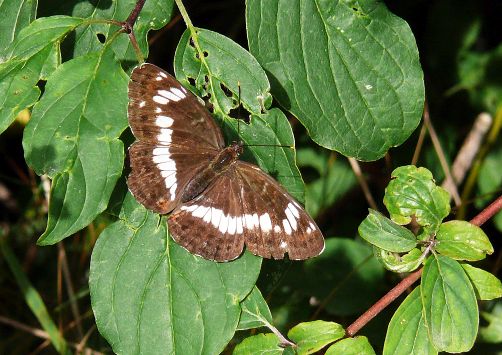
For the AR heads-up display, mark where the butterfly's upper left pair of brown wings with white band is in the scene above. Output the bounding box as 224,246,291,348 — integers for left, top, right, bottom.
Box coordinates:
128,64,224,214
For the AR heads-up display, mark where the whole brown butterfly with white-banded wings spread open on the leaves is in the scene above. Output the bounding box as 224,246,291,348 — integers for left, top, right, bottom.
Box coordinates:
127,63,324,261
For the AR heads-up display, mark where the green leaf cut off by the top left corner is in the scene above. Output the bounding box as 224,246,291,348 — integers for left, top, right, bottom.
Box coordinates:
0,0,38,52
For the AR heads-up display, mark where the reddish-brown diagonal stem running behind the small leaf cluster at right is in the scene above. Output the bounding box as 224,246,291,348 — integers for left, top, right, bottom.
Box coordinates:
346,196,502,337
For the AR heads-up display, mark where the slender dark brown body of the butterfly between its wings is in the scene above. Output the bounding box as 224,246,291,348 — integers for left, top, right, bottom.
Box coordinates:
181,143,242,203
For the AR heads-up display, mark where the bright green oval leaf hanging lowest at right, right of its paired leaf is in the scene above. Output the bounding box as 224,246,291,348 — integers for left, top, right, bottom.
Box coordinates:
420,255,479,352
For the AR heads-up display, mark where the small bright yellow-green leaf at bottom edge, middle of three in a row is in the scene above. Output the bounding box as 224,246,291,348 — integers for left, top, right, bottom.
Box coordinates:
288,320,345,355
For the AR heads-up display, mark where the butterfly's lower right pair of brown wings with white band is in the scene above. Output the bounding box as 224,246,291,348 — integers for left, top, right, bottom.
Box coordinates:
168,161,324,261
